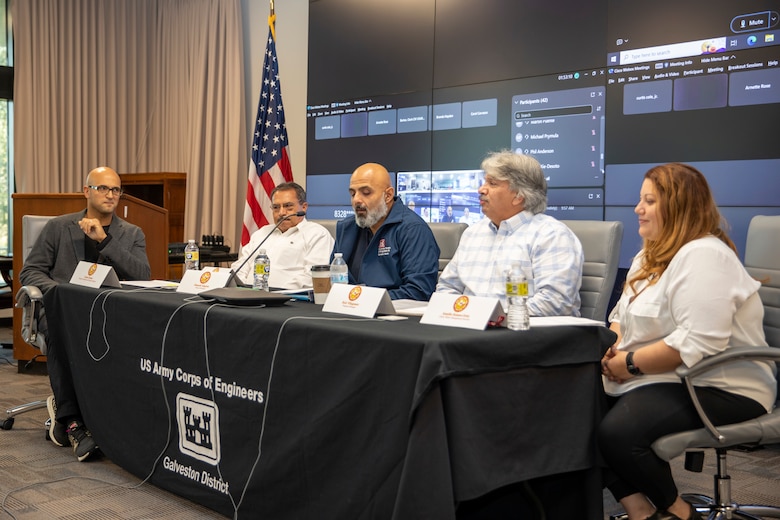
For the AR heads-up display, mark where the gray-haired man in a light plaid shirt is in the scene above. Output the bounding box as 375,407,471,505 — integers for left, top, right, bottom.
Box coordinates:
436,151,584,316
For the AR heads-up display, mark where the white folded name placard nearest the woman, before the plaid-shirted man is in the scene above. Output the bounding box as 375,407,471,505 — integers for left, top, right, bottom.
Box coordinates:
420,293,506,330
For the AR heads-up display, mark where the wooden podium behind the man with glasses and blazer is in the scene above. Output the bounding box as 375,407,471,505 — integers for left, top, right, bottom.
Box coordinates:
11,193,168,367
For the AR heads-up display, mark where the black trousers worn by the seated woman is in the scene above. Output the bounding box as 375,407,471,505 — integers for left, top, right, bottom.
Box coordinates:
598,383,766,509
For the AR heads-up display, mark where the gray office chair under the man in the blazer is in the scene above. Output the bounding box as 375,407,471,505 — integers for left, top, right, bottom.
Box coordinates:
0,215,54,435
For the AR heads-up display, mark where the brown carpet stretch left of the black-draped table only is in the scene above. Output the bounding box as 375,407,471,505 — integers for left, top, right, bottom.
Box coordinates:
0,319,225,520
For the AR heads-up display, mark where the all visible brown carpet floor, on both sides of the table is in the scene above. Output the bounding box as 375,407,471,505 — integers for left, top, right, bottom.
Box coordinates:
0,317,780,520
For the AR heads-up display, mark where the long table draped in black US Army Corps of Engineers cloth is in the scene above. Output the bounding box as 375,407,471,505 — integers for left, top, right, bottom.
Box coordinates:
44,284,614,520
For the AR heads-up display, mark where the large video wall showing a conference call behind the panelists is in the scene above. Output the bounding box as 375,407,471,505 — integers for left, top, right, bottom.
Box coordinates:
306,0,780,267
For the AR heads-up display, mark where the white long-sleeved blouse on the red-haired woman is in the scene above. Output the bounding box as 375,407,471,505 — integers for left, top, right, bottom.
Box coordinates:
604,236,777,411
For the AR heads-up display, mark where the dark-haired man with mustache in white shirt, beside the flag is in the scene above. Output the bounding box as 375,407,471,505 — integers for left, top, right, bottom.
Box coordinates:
230,182,333,289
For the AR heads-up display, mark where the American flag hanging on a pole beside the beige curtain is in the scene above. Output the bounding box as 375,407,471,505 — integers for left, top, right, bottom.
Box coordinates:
241,12,293,246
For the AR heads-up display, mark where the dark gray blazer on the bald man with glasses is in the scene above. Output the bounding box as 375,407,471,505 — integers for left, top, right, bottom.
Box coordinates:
19,209,151,293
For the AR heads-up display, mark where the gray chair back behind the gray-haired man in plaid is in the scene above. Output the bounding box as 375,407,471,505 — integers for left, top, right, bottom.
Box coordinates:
561,220,623,321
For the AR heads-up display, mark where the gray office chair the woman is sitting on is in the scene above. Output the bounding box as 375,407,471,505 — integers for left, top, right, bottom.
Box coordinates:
653,216,780,520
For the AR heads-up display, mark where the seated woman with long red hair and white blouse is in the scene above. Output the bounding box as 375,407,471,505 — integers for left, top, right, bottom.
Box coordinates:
599,163,777,520
